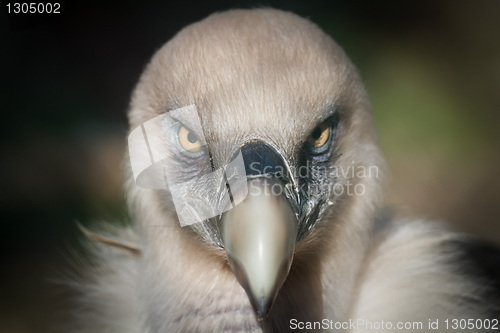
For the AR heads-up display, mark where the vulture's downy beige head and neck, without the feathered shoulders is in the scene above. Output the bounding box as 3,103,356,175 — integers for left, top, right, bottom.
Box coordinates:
128,10,382,331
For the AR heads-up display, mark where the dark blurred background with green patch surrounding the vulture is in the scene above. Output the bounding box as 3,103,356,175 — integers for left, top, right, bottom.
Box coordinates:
0,0,500,333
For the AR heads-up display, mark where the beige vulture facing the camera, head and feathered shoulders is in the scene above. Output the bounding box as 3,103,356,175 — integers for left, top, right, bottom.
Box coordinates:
74,9,500,333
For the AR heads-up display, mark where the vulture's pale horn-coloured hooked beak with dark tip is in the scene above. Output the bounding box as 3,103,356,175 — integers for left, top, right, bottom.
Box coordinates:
221,142,298,320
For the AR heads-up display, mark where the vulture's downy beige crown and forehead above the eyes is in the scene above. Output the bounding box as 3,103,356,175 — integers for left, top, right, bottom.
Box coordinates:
130,11,358,160
